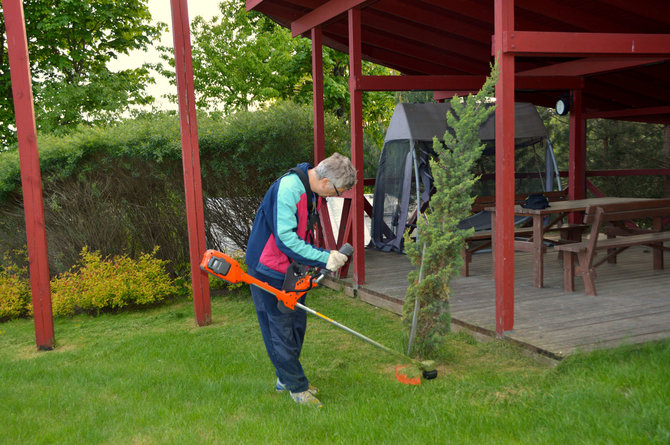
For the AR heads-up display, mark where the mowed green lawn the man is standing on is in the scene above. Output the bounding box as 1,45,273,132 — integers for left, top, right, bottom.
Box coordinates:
0,289,670,444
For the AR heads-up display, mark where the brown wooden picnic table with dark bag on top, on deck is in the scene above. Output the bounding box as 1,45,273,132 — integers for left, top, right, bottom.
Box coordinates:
486,196,649,287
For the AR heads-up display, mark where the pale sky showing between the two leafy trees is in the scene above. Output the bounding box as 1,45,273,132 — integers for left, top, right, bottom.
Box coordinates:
110,0,221,109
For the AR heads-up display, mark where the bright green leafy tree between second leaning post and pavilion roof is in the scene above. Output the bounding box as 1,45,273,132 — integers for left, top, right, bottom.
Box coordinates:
157,0,395,146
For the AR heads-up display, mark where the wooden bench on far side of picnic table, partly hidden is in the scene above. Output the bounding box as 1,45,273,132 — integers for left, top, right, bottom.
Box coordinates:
461,190,587,277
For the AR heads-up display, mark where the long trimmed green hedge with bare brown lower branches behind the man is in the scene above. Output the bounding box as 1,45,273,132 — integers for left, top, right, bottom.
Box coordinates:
0,103,349,274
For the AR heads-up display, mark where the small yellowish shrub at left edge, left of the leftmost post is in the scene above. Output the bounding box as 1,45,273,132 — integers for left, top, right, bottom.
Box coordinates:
0,251,33,321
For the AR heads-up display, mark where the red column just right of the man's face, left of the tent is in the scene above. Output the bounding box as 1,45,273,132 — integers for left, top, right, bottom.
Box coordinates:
350,7,365,286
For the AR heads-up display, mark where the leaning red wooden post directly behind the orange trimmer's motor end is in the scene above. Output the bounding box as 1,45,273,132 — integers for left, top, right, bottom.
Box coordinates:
170,0,212,326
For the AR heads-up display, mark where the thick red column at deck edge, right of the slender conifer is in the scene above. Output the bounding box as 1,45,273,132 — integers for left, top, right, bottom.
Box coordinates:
494,0,515,336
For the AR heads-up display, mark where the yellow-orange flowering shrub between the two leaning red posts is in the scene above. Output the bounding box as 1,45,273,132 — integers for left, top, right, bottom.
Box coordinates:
51,247,180,315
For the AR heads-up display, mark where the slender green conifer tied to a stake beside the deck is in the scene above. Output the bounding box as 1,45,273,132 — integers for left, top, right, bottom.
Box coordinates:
403,67,497,356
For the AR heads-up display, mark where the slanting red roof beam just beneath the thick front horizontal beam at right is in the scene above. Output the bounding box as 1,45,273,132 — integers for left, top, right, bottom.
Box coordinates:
516,56,668,77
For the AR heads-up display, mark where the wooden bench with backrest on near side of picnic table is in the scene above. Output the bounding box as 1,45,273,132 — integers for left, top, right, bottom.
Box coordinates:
554,199,670,295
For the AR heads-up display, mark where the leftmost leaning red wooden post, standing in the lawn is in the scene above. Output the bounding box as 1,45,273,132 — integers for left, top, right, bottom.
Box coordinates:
2,0,55,350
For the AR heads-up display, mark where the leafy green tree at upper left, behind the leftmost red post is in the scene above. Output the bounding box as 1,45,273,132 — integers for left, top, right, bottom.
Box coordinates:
0,0,164,147
